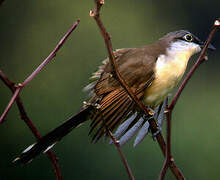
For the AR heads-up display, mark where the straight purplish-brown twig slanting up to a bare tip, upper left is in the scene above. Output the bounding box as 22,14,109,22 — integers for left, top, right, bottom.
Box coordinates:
0,19,80,123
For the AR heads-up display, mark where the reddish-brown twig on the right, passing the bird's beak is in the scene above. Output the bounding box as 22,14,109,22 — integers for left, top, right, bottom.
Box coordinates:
159,19,220,180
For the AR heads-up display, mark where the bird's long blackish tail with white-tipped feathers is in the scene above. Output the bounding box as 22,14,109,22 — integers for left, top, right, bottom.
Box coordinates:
13,106,93,164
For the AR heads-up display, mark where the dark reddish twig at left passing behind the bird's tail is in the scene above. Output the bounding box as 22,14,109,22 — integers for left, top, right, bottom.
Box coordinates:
0,70,62,180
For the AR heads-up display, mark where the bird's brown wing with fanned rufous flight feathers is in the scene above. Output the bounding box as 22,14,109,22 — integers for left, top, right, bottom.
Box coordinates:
85,47,159,141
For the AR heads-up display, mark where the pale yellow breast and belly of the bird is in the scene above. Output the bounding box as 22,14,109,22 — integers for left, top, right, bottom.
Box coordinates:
143,52,191,108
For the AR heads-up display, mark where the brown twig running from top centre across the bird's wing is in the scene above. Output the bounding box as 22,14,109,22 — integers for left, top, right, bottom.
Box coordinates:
90,0,184,180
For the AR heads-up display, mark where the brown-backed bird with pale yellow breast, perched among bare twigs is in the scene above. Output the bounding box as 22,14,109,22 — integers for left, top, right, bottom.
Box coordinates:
14,30,215,164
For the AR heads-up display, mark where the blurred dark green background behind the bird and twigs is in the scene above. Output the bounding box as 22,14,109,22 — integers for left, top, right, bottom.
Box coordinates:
0,0,220,180
